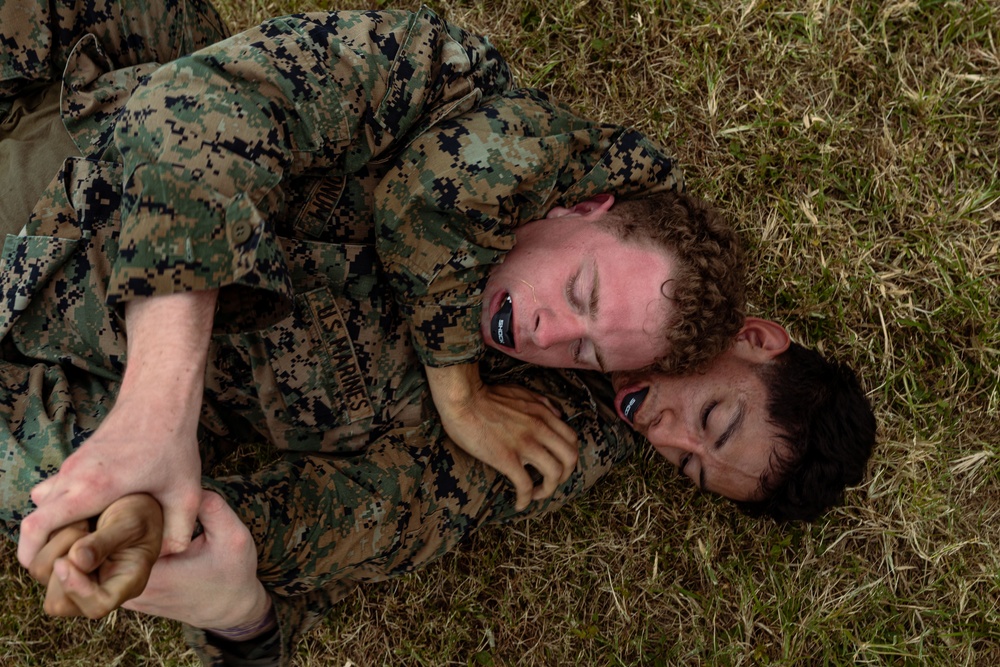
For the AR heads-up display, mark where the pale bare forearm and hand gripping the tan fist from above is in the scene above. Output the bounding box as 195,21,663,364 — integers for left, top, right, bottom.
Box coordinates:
17,291,217,567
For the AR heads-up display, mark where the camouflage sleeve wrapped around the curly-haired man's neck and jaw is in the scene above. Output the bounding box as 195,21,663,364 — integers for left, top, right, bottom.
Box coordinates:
375,89,680,366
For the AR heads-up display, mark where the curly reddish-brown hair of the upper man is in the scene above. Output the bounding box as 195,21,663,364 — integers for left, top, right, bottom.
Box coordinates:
598,190,746,373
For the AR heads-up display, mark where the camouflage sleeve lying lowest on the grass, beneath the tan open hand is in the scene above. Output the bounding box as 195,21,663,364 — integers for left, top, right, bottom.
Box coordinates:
205,362,636,656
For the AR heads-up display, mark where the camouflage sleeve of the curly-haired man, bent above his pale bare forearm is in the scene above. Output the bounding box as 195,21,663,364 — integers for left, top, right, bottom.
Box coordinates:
109,9,509,331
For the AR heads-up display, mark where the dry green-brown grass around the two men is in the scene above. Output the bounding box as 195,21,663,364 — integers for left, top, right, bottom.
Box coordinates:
0,0,1000,667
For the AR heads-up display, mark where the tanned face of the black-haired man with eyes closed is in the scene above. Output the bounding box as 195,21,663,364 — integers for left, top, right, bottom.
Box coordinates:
614,343,783,500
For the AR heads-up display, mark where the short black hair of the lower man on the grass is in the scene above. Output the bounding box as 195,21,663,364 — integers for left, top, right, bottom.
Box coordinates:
737,343,876,521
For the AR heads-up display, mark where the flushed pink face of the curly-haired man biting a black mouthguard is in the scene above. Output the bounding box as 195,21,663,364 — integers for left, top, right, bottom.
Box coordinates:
481,201,674,371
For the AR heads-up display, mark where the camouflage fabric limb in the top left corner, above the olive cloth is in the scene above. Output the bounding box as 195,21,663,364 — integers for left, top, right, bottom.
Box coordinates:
0,0,229,98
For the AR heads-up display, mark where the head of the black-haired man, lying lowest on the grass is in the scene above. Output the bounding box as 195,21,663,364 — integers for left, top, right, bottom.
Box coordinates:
614,317,875,520
